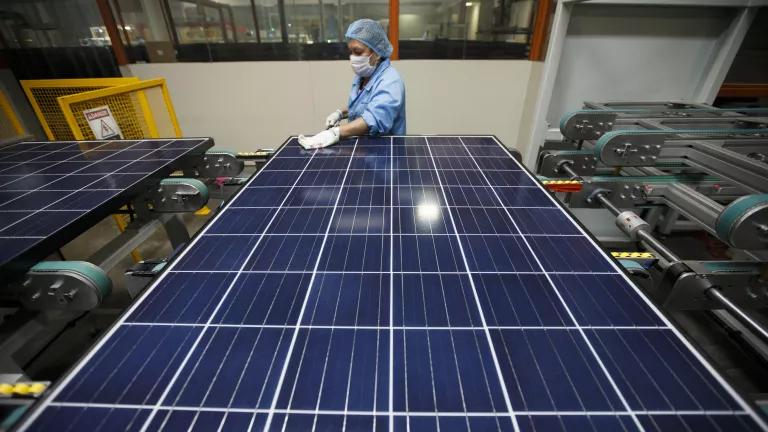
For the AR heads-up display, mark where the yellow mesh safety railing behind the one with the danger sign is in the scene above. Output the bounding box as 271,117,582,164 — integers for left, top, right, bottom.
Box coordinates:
21,77,139,141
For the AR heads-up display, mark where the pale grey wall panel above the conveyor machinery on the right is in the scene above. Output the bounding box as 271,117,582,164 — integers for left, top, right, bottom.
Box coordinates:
547,3,736,127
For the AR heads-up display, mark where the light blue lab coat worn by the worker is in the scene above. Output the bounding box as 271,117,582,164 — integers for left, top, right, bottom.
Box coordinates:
347,59,405,135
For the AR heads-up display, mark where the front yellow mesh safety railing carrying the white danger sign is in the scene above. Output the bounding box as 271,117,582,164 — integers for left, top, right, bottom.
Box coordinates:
57,78,181,140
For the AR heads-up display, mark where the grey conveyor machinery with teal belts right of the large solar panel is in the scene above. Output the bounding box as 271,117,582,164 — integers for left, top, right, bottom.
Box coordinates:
537,101,768,410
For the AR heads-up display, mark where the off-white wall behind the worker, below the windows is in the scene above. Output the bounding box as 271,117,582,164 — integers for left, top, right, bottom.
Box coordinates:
129,60,532,151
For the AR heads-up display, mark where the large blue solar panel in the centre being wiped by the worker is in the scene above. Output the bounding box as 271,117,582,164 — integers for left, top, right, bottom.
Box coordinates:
15,137,765,431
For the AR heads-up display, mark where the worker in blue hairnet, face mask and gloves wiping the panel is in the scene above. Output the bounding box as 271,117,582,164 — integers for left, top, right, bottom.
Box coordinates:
299,19,405,149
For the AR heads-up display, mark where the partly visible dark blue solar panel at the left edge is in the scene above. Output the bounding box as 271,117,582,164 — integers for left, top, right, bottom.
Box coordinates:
0,138,213,272
